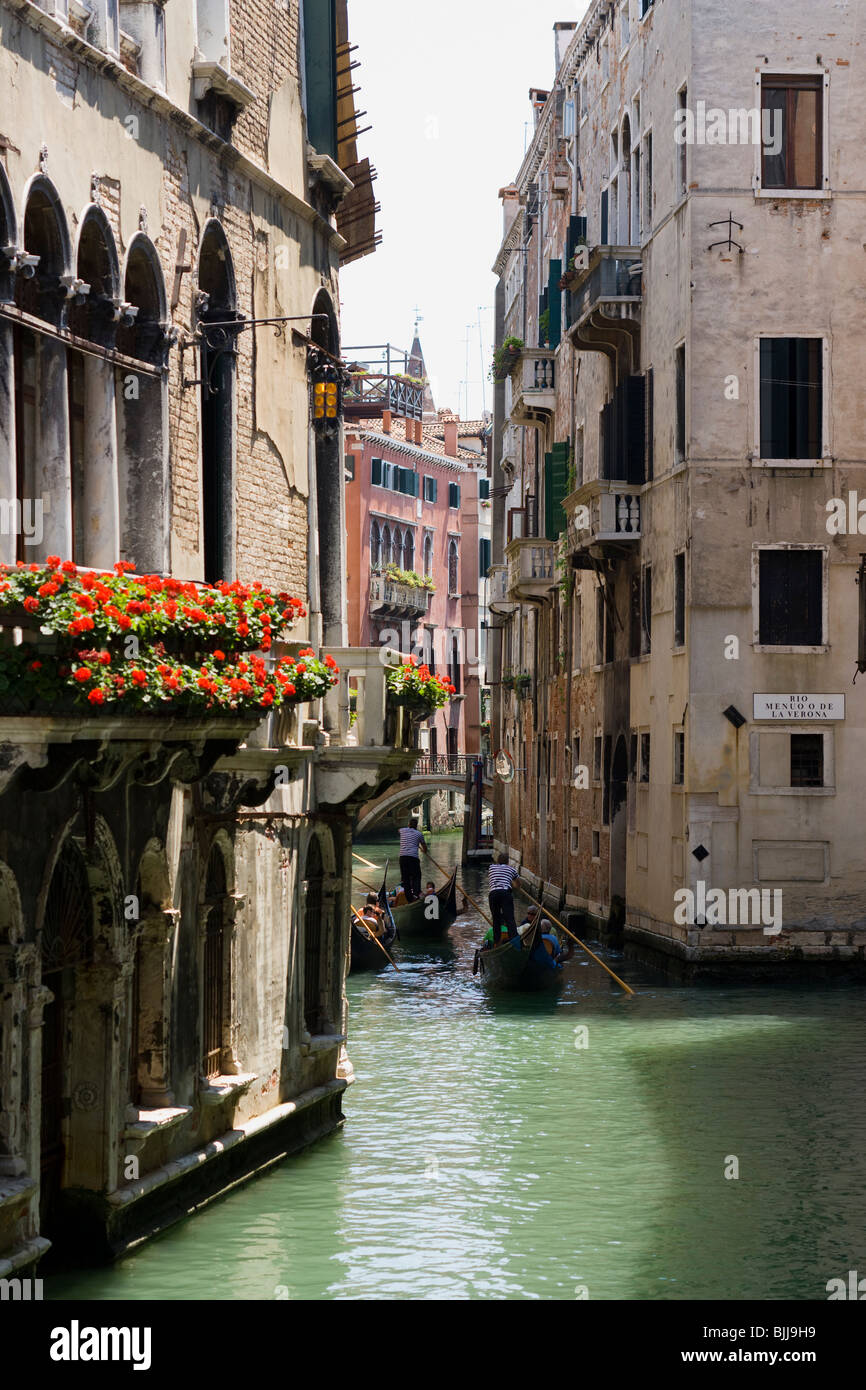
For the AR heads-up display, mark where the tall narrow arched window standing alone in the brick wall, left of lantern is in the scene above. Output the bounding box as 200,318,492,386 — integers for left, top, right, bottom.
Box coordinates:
197,218,238,584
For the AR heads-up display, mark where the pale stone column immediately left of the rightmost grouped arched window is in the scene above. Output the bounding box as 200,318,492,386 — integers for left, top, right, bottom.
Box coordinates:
81,354,121,570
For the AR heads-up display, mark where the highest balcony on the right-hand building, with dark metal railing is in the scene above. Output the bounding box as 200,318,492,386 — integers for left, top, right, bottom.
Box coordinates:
567,246,644,371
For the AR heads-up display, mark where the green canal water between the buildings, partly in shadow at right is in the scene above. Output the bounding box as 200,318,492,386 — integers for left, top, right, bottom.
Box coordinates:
46,837,866,1300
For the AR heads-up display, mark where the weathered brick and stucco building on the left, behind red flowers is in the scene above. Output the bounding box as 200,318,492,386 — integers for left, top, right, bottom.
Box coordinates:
0,0,411,1273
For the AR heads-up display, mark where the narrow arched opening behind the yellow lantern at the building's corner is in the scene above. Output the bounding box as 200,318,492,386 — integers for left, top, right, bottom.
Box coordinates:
310,289,346,646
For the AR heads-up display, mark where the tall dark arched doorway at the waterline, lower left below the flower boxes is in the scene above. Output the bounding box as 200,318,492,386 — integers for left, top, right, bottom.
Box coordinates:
40,840,93,1233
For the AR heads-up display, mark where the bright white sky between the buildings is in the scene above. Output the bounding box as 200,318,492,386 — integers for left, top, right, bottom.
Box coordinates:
341,0,587,418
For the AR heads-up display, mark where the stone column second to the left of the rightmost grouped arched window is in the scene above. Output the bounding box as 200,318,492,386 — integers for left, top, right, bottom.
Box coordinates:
28,334,72,560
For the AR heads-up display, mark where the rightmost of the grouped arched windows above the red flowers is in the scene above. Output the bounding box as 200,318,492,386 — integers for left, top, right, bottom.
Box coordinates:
117,232,170,574
